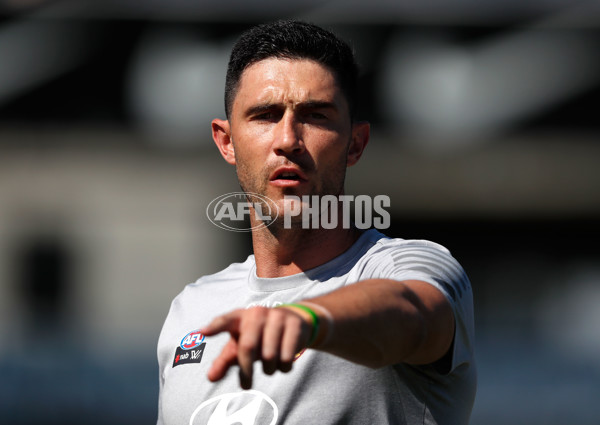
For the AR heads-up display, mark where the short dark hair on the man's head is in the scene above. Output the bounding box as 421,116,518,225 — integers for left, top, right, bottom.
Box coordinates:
225,20,358,118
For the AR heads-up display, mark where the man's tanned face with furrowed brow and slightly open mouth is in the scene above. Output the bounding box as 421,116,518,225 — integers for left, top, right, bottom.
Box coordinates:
221,58,362,210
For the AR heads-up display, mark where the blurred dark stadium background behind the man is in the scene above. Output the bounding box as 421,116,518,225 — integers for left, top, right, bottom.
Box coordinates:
0,0,600,425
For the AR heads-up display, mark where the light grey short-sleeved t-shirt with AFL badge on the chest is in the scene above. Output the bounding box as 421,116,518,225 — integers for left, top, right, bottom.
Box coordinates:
158,230,476,425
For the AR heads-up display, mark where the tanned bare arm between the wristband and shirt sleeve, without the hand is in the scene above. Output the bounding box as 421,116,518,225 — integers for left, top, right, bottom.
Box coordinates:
286,279,454,367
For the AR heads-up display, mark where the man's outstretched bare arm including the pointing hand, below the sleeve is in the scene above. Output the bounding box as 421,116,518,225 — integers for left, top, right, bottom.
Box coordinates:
201,279,454,389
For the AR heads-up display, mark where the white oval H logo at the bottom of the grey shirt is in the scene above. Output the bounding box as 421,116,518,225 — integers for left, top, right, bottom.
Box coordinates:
189,390,279,425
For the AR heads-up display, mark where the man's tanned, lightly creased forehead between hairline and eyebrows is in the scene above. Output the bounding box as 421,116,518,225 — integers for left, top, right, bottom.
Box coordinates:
233,58,347,113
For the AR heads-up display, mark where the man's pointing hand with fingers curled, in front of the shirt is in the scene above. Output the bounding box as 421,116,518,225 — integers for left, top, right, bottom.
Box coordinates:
201,307,312,389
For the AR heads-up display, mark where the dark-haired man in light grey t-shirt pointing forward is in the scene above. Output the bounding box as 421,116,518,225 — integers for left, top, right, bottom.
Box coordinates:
158,21,476,425
